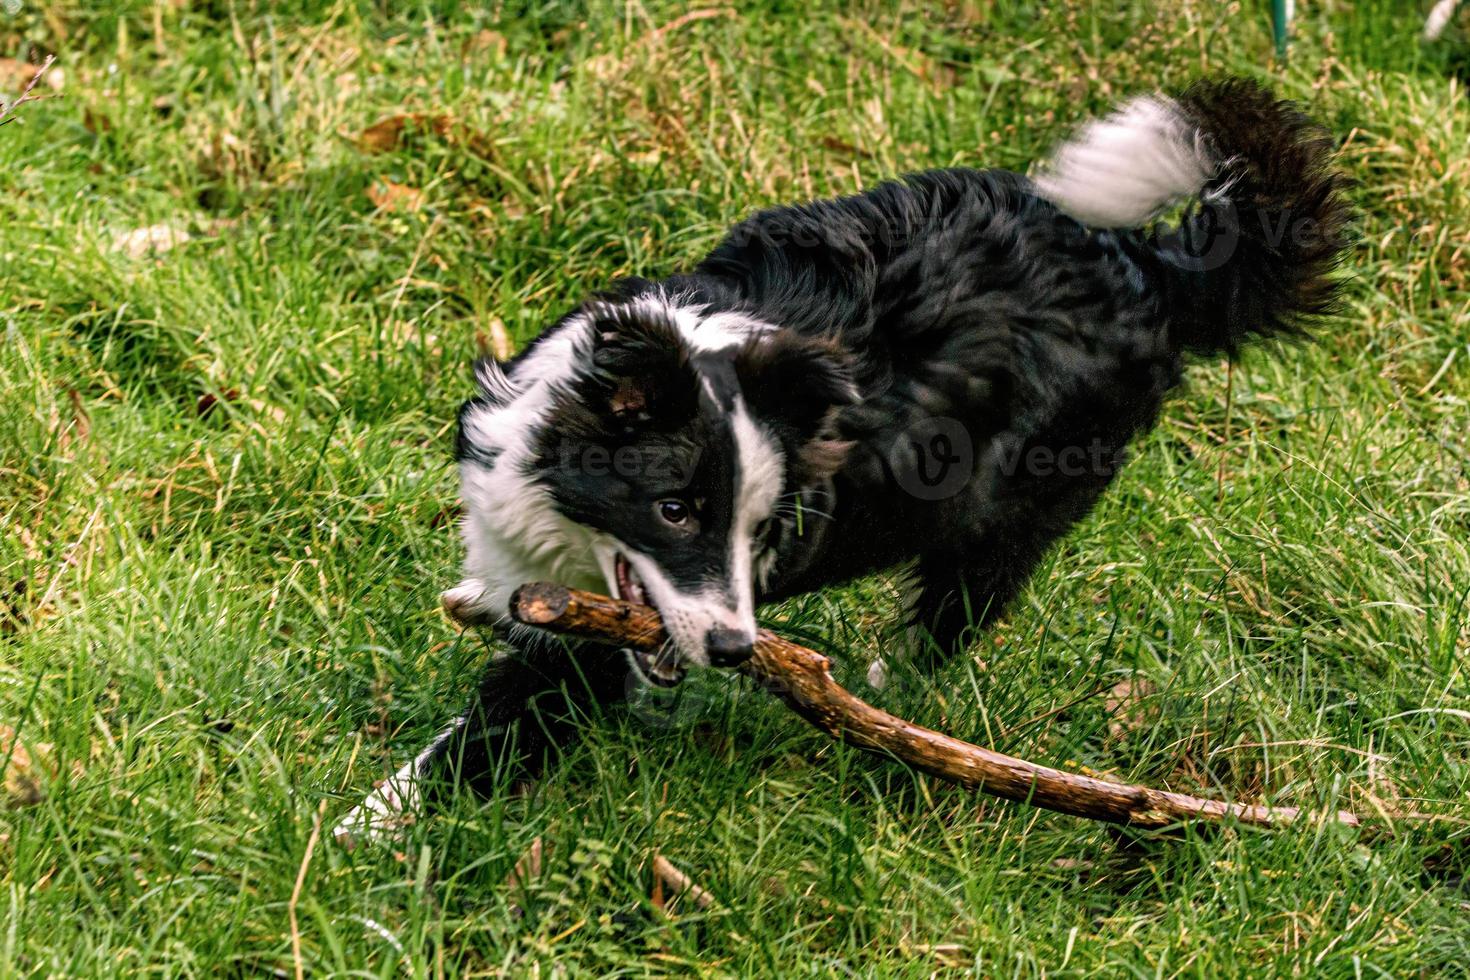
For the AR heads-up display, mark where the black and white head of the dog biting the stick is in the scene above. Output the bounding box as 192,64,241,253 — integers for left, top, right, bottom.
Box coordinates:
462,300,856,683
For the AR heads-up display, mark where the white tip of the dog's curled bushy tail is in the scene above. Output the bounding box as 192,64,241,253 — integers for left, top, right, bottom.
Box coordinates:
1035,96,1216,228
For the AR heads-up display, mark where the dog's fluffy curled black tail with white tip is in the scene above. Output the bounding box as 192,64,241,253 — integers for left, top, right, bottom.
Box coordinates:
1035,79,1351,354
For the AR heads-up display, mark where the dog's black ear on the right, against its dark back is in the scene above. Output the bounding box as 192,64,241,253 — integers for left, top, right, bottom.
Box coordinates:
735,331,858,435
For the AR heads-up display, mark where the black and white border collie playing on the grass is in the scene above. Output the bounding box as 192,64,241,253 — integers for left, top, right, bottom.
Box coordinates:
338,79,1349,836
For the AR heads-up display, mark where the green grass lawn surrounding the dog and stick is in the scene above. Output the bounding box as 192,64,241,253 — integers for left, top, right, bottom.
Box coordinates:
0,0,1470,977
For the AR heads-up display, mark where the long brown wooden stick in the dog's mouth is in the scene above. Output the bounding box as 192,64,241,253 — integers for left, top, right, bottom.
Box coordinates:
510,582,1361,829
